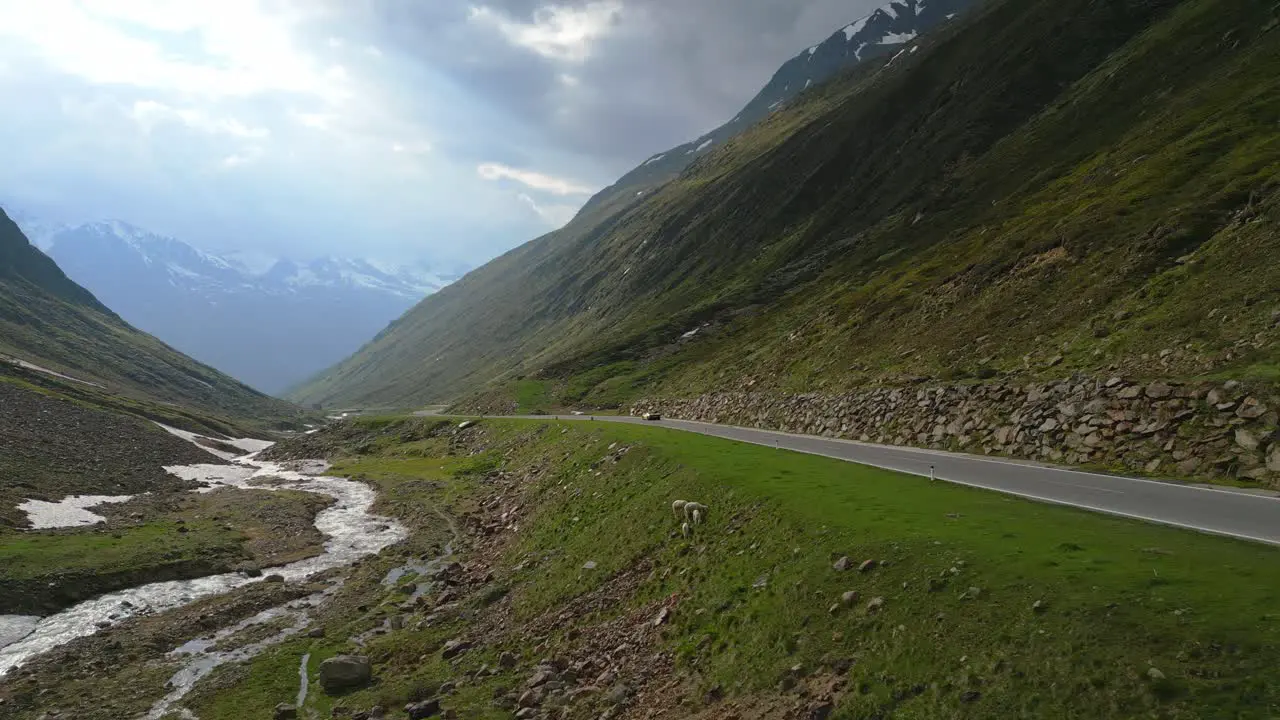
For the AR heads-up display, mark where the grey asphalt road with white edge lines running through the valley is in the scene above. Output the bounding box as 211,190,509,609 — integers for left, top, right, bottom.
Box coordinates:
481,415,1280,544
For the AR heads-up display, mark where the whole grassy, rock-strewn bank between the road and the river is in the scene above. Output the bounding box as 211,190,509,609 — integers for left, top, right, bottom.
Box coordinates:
99,419,1280,720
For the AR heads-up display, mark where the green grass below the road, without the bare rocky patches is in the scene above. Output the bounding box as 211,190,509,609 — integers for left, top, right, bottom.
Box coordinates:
180,420,1280,719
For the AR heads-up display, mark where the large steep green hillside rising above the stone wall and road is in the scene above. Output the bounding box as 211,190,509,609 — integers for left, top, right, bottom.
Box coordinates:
293,0,1280,405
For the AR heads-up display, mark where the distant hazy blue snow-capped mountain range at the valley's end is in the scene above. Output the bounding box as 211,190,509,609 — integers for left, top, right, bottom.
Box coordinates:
18,215,453,393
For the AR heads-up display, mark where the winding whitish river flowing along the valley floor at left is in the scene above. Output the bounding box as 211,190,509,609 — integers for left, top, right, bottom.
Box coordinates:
0,443,407,675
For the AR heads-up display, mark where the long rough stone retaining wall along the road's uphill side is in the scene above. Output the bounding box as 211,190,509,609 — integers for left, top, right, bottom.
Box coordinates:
631,377,1280,487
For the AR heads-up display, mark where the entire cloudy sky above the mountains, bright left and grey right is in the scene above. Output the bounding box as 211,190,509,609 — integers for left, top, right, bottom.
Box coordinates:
0,0,878,264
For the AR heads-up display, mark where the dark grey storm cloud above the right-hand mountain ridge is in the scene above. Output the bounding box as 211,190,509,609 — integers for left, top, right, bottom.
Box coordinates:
367,0,882,170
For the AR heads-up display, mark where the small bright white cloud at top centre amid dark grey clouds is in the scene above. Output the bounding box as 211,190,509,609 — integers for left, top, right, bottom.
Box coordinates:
470,0,622,63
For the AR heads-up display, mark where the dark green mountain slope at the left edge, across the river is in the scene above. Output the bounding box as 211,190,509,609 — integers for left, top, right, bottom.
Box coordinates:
0,210,298,419
